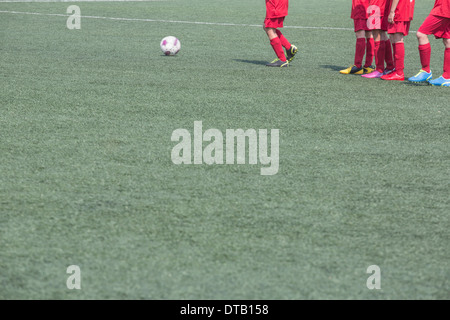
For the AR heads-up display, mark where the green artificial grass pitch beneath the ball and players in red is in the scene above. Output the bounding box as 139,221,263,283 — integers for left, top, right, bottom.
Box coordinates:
0,0,450,300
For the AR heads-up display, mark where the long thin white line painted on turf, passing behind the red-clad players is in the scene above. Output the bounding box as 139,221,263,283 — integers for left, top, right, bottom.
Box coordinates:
0,9,353,31
